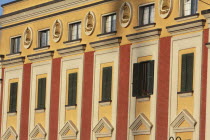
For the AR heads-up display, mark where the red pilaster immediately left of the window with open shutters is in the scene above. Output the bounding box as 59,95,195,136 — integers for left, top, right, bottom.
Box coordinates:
116,45,130,140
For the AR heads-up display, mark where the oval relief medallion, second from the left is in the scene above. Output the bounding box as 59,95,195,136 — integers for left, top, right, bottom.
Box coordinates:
52,19,63,42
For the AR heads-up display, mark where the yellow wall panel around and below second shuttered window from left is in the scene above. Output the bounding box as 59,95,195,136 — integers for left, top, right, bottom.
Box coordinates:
34,74,47,127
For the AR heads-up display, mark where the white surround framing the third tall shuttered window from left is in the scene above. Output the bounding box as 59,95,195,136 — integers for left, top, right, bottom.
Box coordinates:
58,55,84,140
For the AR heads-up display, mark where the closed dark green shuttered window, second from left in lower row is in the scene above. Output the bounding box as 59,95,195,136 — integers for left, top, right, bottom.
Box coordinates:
37,78,46,109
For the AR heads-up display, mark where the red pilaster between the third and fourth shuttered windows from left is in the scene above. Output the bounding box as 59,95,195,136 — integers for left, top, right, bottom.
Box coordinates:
80,52,94,140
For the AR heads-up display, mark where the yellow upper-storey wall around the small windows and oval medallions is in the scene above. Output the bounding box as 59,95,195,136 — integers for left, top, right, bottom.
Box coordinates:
0,0,209,63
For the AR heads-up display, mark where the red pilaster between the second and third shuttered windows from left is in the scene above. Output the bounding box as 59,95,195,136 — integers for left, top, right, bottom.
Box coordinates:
49,58,61,140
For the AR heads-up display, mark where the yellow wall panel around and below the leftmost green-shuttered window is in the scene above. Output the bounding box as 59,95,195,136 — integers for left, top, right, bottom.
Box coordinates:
7,79,19,129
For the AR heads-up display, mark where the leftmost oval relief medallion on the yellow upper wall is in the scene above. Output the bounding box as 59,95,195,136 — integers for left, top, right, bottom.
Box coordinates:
23,27,33,49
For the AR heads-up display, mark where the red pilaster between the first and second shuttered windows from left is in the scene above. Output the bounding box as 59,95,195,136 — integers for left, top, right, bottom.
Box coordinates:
20,64,31,140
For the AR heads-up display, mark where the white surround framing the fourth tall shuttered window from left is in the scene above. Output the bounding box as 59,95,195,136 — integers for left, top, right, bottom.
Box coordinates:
91,48,119,140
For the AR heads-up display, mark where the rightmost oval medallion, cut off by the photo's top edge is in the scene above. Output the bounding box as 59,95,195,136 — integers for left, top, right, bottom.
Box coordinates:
159,0,172,18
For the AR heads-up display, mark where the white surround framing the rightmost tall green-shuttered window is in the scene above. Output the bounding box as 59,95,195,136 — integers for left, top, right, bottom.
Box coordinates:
168,32,203,140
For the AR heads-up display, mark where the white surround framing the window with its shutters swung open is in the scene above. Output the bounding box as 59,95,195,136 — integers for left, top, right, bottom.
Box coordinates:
128,40,159,140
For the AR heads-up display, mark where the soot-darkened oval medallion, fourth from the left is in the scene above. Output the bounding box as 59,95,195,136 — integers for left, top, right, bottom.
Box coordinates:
119,2,132,28
